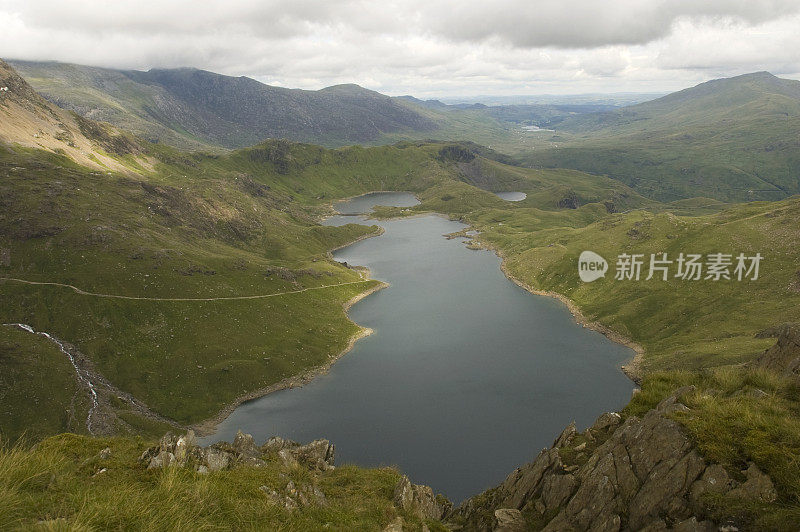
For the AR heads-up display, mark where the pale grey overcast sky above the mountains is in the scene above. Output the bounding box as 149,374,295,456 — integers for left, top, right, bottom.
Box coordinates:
0,0,800,98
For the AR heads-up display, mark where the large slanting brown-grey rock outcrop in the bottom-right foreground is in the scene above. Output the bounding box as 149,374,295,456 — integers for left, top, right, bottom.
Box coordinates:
454,387,777,531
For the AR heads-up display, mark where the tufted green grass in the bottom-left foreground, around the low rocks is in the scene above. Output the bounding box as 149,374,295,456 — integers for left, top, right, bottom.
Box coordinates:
0,434,432,531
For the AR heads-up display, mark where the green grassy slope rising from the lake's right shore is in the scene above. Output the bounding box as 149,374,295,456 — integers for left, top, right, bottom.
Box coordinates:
477,200,800,369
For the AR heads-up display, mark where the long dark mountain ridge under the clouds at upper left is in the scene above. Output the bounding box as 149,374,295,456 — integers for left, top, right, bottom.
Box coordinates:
6,61,436,149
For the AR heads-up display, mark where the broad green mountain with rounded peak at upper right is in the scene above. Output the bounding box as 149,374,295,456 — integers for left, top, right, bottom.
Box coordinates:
524,72,800,201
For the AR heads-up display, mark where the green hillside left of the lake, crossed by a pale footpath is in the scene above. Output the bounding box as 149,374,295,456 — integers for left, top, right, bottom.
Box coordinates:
0,142,390,432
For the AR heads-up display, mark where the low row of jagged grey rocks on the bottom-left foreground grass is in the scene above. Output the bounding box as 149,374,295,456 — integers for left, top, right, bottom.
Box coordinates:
139,430,334,473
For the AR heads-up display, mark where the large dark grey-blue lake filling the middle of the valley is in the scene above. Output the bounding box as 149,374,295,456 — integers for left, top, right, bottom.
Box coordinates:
204,193,634,503
